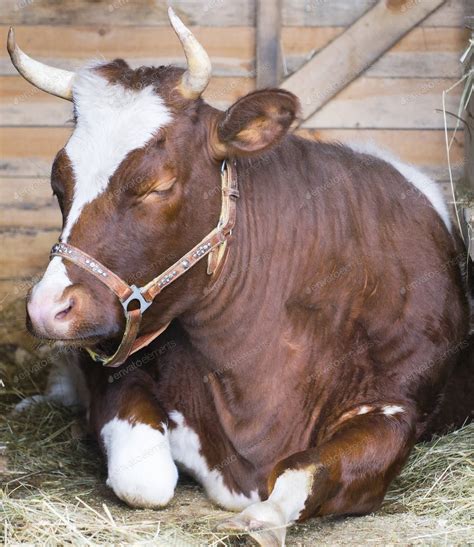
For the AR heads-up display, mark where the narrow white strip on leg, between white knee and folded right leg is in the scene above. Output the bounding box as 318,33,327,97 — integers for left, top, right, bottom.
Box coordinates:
170,410,260,511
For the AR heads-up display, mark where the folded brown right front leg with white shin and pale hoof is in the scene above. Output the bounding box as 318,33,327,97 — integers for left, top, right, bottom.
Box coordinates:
219,404,415,545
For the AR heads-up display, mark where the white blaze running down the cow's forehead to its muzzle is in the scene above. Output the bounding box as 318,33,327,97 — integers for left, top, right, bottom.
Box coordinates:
31,65,172,314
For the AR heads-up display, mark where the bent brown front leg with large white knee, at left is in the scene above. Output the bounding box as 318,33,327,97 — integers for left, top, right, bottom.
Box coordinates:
90,371,178,508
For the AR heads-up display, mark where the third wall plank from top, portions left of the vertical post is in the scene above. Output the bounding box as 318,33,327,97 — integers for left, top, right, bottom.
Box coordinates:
0,76,255,126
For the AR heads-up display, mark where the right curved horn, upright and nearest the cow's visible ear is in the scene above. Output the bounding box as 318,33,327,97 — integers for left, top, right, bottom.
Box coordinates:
168,7,212,99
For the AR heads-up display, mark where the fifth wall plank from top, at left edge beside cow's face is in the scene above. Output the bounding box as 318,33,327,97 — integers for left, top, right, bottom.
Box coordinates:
0,177,61,230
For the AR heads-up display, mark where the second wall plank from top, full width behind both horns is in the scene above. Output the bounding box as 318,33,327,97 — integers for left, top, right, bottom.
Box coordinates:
0,25,469,78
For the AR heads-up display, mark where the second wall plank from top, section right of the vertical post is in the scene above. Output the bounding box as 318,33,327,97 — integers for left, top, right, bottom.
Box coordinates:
282,26,469,78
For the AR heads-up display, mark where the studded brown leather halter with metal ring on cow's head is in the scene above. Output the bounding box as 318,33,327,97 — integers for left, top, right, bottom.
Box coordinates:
50,160,239,367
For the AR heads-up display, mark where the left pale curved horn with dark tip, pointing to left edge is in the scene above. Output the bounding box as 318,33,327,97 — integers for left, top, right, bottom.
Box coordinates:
7,27,75,101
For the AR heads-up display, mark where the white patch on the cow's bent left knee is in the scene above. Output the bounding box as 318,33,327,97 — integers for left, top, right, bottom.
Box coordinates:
101,418,178,508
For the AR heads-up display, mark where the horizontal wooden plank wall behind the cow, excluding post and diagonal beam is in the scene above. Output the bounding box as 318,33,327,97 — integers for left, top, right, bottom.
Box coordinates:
0,0,471,306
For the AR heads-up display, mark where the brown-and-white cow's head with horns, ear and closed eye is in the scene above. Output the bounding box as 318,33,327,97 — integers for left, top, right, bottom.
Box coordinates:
8,8,298,345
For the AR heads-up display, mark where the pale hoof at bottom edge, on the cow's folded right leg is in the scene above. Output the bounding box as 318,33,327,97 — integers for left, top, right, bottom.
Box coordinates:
217,514,286,547
